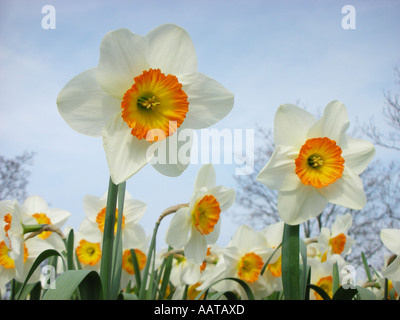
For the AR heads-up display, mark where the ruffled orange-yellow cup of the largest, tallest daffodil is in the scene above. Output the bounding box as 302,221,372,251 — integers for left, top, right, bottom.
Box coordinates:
121,69,189,142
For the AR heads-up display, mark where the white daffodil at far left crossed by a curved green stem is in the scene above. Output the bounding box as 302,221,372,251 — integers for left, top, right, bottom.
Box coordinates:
21,196,71,252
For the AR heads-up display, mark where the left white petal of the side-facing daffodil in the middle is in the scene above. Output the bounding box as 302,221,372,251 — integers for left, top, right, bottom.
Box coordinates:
165,207,191,249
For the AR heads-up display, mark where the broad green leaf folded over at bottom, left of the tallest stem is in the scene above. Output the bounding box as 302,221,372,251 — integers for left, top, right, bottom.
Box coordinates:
43,270,103,300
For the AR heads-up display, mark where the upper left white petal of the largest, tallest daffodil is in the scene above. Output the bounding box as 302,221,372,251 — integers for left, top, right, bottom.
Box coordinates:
96,29,148,99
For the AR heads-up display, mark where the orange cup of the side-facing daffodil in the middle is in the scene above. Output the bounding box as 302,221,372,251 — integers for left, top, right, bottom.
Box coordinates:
192,195,221,235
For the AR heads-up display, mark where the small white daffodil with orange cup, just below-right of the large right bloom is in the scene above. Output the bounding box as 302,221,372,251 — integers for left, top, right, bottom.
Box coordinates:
318,213,355,262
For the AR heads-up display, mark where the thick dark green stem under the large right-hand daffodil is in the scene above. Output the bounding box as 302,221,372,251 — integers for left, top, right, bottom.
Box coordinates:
282,223,301,300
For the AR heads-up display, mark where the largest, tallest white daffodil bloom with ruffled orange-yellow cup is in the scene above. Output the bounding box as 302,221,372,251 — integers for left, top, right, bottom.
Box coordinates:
57,24,233,184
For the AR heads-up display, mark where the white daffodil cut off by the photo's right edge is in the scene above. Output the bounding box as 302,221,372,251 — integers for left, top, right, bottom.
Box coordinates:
381,229,400,285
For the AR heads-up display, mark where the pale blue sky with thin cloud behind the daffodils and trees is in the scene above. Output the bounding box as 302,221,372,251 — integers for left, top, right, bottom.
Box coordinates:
0,0,400,245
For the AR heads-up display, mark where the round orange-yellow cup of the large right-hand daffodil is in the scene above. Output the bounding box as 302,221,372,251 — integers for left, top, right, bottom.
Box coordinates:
295,138,344,188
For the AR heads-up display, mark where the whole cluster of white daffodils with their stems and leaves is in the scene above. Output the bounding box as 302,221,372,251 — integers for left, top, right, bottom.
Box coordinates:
0,24,400,300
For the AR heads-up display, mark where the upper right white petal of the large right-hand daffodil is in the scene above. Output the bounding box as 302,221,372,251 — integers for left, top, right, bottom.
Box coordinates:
307,101,350,145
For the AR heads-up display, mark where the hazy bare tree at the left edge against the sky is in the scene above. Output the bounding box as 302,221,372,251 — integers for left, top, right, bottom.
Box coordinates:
0,151,34,202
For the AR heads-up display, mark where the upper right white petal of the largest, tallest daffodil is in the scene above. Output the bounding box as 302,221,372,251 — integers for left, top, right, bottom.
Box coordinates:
146,24,197,75
